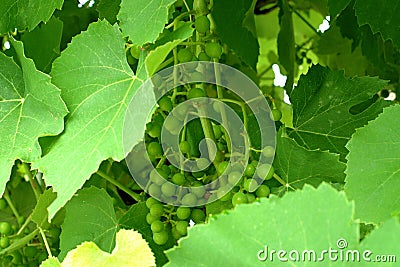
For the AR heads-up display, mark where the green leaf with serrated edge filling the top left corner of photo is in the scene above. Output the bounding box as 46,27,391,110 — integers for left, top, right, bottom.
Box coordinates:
0,0,64,34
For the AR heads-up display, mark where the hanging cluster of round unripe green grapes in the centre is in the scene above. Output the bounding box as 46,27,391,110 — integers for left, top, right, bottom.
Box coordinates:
131,0,282,245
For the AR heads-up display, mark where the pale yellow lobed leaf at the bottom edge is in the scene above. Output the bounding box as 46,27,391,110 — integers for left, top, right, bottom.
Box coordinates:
40,230,155,267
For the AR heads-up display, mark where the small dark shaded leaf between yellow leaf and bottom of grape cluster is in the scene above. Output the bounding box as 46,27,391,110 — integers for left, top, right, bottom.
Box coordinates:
118,202,174,266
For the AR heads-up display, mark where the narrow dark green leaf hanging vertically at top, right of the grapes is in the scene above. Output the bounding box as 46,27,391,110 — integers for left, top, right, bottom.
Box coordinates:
278,0,295,94
